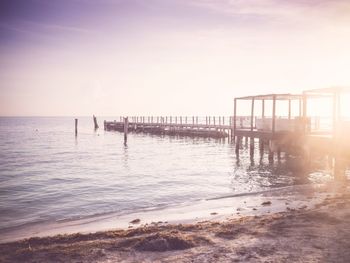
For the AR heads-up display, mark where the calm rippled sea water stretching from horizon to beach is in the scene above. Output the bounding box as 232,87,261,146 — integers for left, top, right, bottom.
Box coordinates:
0,117,329,233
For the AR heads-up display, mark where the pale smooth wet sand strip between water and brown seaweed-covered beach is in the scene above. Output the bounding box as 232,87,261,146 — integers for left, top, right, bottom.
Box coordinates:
0,184,334,244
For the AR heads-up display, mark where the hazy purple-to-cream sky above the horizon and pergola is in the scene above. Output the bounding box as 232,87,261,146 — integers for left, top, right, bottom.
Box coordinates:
0,0,350,116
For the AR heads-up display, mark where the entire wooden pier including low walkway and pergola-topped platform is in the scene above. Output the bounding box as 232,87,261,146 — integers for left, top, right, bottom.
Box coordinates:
104,88,350,178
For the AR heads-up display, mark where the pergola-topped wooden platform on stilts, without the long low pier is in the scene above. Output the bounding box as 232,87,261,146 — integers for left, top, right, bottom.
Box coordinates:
233,88,350,179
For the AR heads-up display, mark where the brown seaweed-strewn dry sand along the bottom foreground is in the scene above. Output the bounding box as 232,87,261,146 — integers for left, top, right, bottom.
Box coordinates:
0,188,350,263
